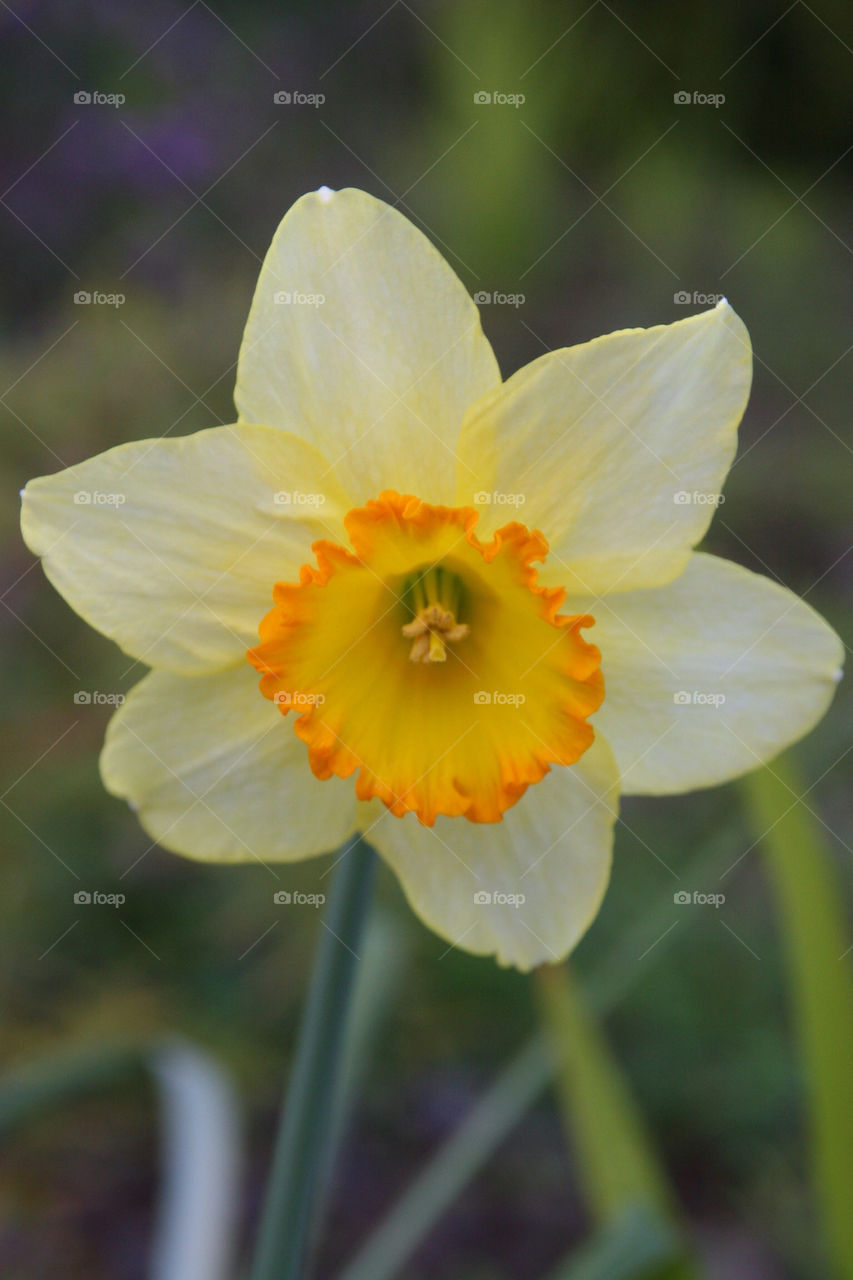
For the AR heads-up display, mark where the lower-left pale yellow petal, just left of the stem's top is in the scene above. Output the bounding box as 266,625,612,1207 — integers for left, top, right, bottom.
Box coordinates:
101,664,356,863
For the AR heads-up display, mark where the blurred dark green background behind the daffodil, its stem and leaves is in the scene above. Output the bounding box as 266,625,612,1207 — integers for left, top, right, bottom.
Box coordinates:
0,0,853,1280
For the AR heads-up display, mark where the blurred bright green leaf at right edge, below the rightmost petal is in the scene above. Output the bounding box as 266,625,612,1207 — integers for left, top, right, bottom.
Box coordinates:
743,758,853,1280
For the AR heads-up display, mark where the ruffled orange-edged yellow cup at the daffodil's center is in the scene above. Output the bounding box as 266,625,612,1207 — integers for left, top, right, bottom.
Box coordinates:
248,490,605,826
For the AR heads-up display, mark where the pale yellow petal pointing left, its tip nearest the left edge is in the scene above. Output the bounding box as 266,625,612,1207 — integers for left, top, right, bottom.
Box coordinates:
22,426,350,673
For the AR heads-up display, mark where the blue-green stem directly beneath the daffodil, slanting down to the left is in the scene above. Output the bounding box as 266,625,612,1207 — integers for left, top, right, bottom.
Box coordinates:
251,836,375,1280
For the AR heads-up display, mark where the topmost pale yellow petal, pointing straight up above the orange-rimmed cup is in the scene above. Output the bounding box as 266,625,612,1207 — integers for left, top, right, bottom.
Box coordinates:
236,189,501,502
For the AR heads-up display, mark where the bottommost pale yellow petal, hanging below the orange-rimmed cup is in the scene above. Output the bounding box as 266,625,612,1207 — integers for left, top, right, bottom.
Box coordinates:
368,736,617,969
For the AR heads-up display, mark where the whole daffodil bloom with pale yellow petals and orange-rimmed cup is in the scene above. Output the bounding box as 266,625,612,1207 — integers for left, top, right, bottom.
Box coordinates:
23,188,841,969
